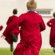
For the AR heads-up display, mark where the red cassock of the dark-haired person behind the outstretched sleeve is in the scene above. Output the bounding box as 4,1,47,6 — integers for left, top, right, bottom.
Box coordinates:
5,16,19,44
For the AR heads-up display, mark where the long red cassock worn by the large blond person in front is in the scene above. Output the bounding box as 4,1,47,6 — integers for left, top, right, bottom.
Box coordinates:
3,11,45,55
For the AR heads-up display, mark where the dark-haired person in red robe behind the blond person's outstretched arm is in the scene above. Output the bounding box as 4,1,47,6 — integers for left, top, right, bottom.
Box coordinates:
5,9,19,44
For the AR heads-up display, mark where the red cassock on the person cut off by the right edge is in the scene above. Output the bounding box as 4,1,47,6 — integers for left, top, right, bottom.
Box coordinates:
47,19,55,47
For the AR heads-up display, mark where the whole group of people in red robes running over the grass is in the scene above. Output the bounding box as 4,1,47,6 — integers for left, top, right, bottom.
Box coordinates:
0,0,55,55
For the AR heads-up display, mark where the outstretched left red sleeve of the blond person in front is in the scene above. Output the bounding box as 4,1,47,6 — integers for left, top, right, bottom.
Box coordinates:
3,14,24,36
